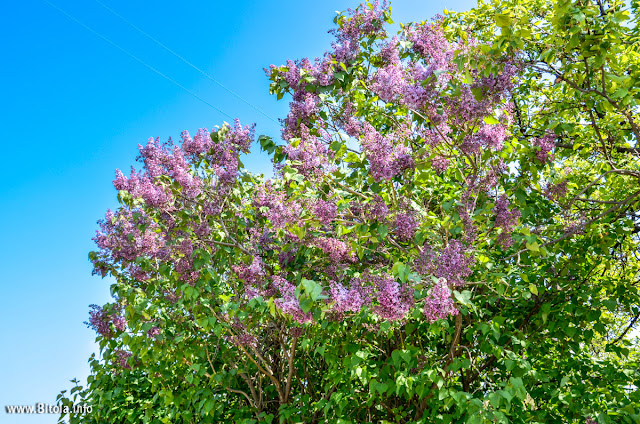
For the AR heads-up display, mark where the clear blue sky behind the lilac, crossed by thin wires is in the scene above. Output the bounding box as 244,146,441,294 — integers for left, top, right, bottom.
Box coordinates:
0,0,475,424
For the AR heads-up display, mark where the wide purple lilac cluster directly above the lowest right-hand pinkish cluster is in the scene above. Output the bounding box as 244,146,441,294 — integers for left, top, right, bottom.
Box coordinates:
415,240,474,287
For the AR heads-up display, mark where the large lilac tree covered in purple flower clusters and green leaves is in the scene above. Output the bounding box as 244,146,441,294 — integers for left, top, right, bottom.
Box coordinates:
61,3,639,423
